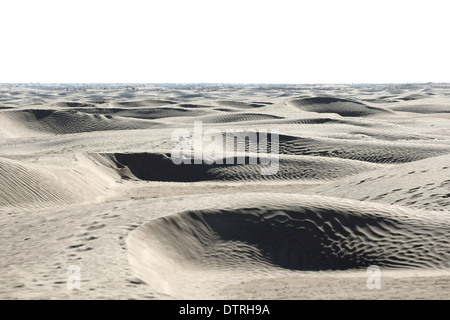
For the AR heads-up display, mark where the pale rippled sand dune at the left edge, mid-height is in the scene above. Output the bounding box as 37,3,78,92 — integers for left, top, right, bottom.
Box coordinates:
0,156,117,207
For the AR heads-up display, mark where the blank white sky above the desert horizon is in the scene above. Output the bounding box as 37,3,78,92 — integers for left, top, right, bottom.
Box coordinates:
0,0,450,83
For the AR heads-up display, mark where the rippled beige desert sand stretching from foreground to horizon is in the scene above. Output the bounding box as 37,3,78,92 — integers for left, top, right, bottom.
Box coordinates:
0,84,450,299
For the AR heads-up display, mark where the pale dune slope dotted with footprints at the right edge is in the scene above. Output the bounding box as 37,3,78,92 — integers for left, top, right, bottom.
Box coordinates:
313,155,450,210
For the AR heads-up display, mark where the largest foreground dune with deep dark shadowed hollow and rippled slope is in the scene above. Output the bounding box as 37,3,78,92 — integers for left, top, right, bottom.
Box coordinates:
127,194,450,292
